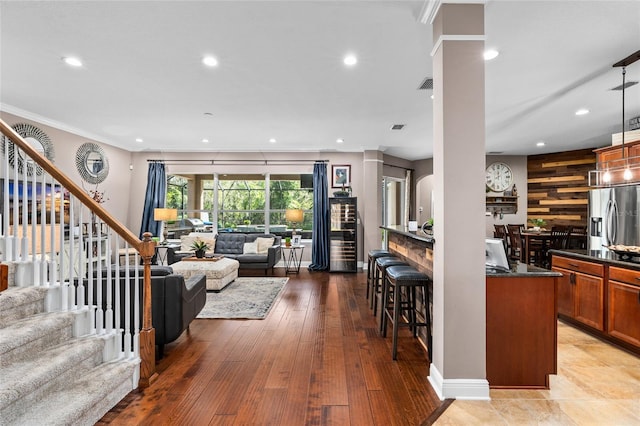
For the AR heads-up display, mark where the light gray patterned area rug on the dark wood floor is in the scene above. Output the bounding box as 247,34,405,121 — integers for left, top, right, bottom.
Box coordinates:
197,277,289,319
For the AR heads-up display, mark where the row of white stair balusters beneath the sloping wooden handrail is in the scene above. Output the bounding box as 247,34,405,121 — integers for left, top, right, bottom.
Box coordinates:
0,131,144,385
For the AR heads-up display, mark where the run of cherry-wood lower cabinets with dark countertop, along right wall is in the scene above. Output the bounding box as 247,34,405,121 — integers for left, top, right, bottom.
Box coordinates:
550,248,640,355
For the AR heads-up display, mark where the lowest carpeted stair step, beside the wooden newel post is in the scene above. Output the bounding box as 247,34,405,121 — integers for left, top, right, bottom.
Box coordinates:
6,361,137,425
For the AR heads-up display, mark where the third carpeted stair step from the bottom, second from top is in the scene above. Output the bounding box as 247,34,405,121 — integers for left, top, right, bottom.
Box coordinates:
0,312,76,366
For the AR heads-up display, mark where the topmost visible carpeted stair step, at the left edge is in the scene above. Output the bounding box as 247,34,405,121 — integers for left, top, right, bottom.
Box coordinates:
0,287,48,329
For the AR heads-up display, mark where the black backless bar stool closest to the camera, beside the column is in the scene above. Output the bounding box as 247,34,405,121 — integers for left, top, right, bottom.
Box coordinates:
381,266,433,360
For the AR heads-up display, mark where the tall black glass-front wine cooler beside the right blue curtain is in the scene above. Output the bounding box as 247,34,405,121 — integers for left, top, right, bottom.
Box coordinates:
329,197,358,272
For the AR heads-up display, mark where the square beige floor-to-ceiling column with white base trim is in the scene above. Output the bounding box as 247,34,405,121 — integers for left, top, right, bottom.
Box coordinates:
429,3,489,399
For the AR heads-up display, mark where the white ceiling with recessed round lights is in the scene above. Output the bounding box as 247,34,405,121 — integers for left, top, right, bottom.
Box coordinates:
0,0,640,160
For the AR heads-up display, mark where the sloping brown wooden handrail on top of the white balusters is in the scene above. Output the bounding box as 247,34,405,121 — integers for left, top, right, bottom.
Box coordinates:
0,119,142,252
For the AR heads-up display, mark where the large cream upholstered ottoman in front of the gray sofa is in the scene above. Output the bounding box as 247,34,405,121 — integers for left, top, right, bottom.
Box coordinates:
171,257,240,291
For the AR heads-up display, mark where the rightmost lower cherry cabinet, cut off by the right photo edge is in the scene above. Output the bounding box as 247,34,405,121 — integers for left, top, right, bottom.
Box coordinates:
607,266,640,347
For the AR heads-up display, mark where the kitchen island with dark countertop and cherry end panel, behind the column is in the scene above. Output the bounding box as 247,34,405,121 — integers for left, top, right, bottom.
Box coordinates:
381,227,562,389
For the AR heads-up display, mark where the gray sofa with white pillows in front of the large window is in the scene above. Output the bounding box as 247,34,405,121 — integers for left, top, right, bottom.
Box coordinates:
214,232,282,273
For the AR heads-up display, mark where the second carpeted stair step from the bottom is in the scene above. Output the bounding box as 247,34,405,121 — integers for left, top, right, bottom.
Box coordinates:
0,337,105,410
